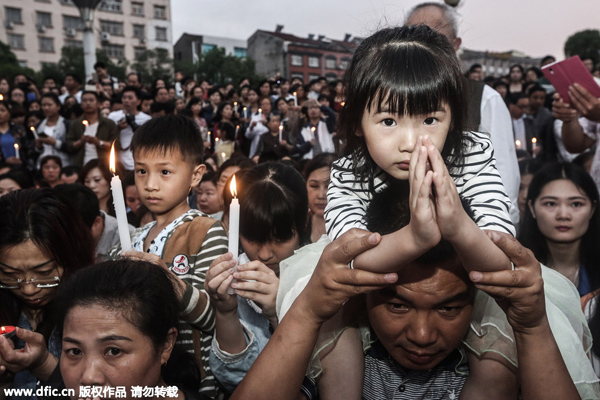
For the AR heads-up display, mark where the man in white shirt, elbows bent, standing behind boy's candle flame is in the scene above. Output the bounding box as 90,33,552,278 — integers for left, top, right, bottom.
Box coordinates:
108,86,150,171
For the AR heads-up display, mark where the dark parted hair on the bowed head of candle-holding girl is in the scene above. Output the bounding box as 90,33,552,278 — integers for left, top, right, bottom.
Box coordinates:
237,162,310,245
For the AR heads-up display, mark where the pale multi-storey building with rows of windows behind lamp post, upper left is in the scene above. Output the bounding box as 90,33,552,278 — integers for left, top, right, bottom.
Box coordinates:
0,0,173,70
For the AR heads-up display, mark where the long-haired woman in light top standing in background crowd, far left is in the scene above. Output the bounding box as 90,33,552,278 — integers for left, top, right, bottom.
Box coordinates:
35,93,71,167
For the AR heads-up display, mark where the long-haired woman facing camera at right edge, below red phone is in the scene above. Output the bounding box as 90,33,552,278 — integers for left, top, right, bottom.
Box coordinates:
519,163,600,296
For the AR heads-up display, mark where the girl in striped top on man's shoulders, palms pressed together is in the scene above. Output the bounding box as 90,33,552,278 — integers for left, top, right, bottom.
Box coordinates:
320,26,592,399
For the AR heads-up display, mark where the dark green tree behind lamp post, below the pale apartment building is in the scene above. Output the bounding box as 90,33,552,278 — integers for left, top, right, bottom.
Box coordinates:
40,46,128,82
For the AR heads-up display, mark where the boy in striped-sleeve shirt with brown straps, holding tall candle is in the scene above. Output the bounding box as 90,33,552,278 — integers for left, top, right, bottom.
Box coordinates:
110,115,228,397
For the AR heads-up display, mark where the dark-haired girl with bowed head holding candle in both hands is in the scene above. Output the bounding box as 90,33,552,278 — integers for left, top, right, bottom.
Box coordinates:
204,163,309,391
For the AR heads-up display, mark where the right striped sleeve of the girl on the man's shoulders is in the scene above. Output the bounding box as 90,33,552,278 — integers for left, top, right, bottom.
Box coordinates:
452,132,516,236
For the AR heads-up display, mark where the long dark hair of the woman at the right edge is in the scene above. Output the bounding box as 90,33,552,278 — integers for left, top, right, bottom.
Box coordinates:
519,163,600,289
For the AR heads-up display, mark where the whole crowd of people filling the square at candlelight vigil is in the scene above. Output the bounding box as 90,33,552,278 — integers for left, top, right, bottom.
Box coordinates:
0,3,600,399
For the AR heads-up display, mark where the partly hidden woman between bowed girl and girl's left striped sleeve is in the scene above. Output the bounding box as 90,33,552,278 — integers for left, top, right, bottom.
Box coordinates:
304,153,336,243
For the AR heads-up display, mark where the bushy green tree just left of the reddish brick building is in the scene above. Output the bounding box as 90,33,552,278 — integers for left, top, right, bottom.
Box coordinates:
176,47,258,85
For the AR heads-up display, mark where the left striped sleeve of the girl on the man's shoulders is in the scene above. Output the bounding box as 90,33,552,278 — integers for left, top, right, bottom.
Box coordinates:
325,157,371,240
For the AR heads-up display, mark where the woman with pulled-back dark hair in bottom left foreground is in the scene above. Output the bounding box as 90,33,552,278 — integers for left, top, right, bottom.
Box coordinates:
0,259,212,400
